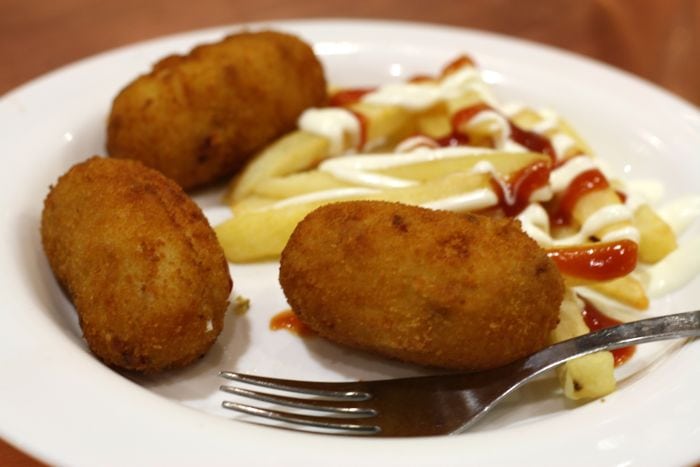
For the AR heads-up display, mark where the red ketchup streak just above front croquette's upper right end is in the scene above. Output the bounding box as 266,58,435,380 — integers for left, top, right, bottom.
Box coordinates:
491,162,549,217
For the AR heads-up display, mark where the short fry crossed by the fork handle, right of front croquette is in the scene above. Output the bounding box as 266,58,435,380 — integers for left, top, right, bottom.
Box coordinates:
551,289,616,400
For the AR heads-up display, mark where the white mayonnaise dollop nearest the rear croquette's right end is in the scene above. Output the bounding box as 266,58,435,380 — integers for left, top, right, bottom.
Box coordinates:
297,107,360,156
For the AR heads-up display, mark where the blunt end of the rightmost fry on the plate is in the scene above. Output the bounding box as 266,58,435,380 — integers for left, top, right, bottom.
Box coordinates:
634,204,678,263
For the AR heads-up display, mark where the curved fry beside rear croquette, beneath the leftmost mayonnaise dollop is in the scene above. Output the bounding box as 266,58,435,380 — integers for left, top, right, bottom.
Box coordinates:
225,130,329,204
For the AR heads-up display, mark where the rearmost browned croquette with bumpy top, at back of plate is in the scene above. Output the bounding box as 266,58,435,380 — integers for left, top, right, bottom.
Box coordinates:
107,31,326,189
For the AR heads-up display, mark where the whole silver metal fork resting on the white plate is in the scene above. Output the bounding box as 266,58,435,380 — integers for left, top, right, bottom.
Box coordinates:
219,311,700,437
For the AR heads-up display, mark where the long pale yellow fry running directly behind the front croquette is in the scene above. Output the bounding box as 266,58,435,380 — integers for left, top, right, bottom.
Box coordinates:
215,173,495,263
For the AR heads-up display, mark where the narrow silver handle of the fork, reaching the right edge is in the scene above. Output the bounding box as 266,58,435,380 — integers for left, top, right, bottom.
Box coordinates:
518,311,700,379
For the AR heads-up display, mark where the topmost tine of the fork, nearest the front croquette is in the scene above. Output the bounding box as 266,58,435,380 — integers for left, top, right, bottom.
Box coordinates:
219,371,372,401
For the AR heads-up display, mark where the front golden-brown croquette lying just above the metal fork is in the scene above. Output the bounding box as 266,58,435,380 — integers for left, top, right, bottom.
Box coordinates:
279,201,564,370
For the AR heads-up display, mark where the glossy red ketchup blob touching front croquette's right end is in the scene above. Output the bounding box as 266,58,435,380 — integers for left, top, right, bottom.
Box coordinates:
547,239,638,281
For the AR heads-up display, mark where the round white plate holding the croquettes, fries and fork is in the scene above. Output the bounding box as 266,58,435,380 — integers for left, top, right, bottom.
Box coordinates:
0,21,700,466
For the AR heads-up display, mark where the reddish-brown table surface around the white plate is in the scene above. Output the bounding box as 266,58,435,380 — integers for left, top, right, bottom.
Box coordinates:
0,0,700,466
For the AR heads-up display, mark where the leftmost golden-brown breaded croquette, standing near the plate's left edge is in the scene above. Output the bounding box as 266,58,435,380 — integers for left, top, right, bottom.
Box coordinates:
41,157,232,372
